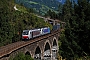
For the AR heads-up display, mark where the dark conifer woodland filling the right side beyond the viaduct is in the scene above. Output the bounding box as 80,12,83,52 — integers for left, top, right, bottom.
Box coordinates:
59,0,90,60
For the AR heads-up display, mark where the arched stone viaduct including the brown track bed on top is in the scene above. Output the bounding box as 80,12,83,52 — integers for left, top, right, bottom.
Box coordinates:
0,30,60,60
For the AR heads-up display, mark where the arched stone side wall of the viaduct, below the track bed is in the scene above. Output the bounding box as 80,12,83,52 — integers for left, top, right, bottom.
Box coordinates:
0,34,58,60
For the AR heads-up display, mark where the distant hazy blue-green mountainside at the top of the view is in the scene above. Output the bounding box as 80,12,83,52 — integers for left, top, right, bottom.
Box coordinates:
15,0,60,15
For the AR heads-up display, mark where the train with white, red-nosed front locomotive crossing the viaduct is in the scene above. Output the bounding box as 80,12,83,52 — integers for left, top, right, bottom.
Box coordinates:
22,25,60,40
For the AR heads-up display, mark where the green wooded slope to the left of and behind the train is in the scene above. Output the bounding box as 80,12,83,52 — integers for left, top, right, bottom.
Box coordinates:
0,0,52,46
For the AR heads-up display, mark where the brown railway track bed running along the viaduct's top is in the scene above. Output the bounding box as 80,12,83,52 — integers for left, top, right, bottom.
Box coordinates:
0,30,60,58
